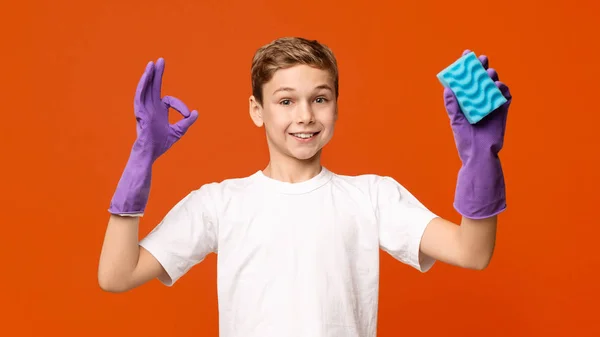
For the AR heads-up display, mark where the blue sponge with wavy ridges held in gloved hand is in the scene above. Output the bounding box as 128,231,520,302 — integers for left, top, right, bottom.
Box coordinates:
437,52,506,124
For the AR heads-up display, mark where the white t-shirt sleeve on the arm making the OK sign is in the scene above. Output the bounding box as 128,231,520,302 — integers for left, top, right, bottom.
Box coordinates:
139,185,218,286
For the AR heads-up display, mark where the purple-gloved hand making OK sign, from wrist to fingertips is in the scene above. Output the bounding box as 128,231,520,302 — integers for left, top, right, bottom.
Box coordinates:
133,58,198,163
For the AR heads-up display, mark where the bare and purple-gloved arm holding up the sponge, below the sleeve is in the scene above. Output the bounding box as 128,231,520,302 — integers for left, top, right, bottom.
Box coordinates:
421,50,512,270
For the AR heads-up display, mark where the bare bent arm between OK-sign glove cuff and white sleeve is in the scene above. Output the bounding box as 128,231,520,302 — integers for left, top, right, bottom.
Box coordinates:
98,214,168,293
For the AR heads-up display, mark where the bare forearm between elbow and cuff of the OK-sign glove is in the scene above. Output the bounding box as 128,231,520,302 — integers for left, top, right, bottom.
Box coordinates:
98,214,140,291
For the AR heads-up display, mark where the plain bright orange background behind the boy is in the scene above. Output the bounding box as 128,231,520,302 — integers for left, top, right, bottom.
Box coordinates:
0,0,600,337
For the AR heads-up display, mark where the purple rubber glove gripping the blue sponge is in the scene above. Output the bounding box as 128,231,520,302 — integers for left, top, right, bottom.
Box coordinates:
444,50,512,219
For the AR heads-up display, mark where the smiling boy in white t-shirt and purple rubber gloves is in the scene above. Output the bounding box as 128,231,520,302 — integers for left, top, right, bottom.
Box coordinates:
98,38,510,337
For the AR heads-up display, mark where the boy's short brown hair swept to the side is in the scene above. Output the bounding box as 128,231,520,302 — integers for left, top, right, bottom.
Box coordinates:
251,37,339,105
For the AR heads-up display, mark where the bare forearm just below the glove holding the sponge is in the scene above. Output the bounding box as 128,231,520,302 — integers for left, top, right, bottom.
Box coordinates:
459,215,498,270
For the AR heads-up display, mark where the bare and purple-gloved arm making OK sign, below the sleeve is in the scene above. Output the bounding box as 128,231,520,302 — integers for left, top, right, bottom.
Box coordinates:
98,58,198,292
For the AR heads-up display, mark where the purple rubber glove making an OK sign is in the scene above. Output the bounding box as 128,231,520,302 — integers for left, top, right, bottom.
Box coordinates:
109,58,198,215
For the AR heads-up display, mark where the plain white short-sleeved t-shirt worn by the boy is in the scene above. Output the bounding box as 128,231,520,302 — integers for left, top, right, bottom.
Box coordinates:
140,167,436,337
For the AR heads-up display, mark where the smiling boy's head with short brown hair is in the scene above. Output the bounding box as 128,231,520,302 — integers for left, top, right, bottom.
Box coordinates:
250,38,339,160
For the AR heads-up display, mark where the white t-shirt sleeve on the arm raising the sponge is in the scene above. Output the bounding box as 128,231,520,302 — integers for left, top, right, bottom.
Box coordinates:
375,177,437,272
